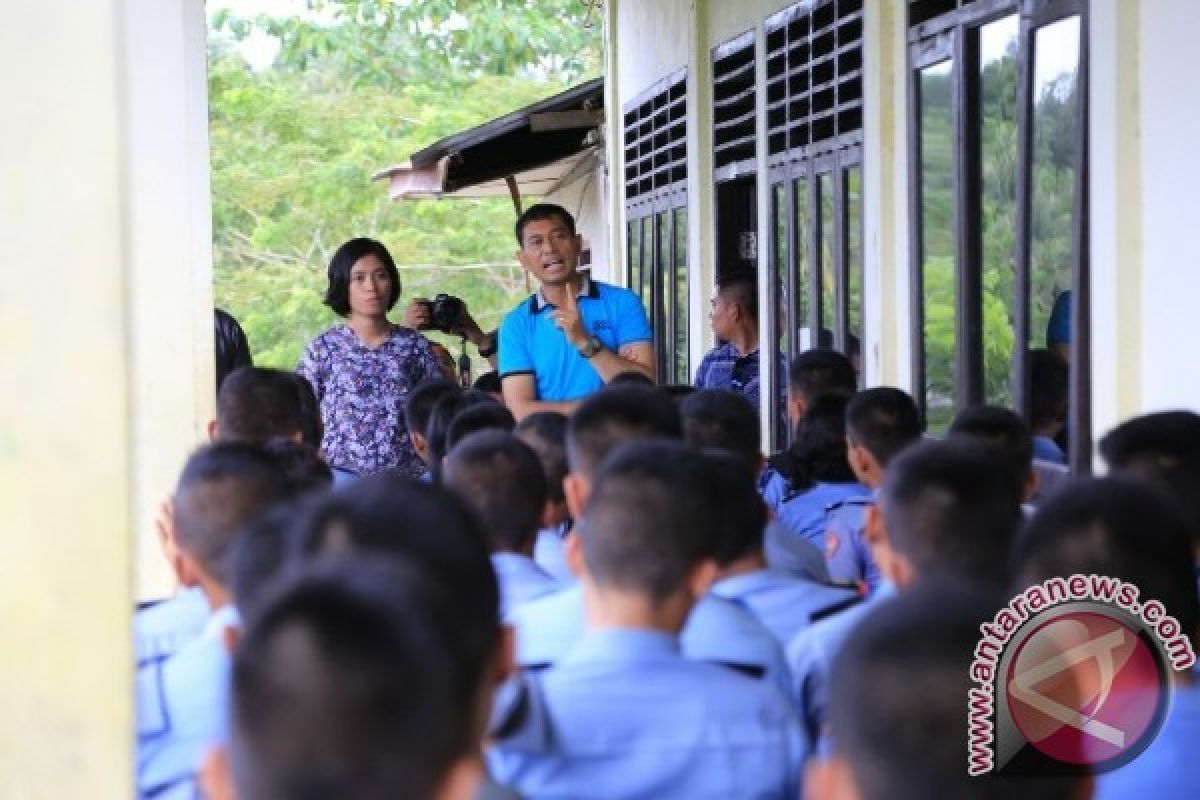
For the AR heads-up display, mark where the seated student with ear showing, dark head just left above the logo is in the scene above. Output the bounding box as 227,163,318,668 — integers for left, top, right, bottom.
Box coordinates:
787,439,1021,762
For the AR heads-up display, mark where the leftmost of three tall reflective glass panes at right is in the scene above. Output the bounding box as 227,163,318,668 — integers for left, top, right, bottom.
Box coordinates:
920,61,955,433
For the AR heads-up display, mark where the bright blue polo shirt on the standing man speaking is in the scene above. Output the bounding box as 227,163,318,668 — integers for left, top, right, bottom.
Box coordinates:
497,278,654,401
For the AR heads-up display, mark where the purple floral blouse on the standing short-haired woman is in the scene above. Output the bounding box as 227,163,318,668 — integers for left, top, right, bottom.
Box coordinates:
296,325,442,477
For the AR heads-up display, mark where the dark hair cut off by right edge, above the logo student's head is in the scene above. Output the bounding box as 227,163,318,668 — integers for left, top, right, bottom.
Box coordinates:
1100,411,1200,548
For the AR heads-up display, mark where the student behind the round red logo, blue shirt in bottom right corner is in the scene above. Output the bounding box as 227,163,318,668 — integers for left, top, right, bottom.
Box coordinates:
1013,477,1200,798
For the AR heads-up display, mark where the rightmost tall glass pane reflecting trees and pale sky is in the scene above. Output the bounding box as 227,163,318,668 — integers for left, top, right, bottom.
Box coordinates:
1030,17,1080,359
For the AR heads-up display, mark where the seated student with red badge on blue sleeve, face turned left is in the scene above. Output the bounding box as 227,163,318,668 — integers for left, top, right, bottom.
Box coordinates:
824,386,920,593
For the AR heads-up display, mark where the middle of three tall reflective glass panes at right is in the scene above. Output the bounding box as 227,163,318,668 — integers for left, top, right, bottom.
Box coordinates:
979,14,1019,407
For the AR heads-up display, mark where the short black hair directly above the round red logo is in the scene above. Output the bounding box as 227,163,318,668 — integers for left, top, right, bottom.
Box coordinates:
1014,477,1200,642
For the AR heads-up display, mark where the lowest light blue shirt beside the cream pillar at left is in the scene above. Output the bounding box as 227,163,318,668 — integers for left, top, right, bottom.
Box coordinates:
137,606,238,798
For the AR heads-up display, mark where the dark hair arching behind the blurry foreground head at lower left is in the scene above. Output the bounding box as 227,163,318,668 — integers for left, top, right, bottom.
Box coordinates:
298,473,499,693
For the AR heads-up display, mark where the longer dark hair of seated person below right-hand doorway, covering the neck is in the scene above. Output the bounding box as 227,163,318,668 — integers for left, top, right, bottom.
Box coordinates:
770,395,856,492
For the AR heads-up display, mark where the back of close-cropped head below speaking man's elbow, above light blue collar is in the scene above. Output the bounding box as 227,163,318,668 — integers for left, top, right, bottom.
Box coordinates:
442,431,546,553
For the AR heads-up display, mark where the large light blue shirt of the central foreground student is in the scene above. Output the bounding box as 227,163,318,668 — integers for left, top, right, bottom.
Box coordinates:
488,628,803,800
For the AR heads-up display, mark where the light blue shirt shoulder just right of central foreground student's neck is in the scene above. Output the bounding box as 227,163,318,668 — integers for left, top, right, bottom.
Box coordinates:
712,570,858,645
